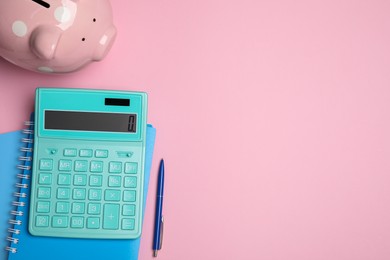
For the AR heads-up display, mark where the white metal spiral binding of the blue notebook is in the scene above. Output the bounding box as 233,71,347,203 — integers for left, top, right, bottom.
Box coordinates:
5,121,34,253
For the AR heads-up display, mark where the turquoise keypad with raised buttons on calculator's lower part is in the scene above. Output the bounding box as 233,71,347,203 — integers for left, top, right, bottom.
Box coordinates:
30,141,143,238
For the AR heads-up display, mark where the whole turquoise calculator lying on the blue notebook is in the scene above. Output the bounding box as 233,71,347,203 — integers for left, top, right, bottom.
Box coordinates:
29,88,147,239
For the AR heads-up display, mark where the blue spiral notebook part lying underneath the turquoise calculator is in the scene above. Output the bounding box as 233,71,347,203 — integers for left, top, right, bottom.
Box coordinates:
0,122,156,260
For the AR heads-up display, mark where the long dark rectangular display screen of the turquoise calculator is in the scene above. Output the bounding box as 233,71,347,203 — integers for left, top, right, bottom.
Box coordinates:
44,110,137,133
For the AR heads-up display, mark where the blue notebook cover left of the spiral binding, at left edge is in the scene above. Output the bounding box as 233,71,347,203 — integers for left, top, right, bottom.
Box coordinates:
0,131,23,260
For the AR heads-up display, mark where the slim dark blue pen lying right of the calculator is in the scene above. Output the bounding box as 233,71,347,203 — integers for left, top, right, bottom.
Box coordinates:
153,159,164,257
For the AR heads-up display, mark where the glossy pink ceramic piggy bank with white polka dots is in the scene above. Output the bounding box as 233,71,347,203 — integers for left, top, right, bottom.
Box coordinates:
0,0,116,73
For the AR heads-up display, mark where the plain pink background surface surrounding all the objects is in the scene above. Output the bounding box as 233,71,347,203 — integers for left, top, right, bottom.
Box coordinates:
0,0,390,260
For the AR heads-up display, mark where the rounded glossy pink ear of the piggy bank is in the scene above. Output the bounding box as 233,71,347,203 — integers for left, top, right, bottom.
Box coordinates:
30,26,62,60
